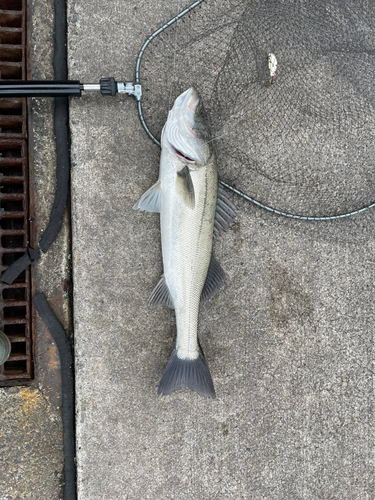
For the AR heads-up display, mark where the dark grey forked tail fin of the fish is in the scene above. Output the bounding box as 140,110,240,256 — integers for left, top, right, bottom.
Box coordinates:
158,349,216,399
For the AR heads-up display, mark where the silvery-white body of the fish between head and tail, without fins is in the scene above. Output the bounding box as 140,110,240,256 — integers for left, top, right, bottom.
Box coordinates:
160,153,218,359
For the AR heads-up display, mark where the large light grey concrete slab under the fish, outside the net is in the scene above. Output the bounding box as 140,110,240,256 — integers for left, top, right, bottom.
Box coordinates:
68,0,375,500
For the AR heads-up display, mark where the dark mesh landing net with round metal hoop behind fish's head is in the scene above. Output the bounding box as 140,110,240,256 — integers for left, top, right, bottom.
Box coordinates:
140,0,375,219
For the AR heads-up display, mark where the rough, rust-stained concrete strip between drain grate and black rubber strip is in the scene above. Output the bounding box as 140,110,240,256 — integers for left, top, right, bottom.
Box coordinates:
0,0,71,500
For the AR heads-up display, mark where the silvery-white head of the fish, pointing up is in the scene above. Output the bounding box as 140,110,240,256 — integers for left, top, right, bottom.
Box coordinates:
161,87,212,168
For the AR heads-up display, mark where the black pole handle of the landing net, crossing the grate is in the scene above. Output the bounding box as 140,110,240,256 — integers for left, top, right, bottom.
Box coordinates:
0,80,83,98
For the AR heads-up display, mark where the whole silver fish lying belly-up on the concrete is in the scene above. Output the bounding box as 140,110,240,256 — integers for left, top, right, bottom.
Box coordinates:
133,87,236,398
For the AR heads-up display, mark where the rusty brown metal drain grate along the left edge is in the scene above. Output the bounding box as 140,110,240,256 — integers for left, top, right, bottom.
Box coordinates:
0,0,33,383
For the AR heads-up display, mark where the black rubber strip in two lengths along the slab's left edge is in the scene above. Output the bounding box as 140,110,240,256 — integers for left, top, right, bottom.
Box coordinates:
33,0,77,500
